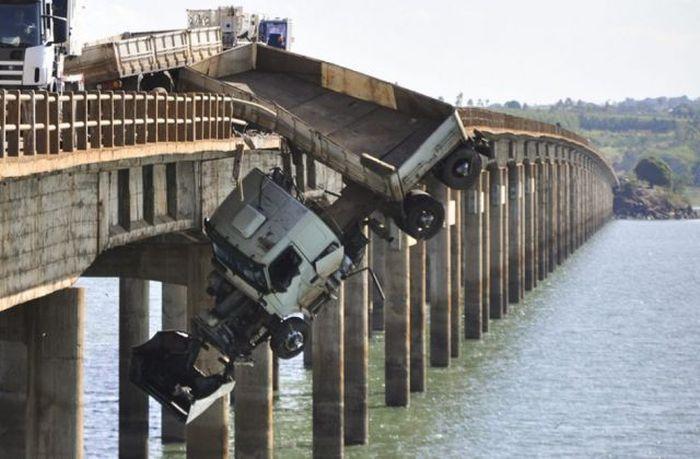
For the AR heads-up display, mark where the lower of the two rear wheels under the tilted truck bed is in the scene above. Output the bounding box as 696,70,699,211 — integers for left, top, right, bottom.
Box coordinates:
394,190,445,240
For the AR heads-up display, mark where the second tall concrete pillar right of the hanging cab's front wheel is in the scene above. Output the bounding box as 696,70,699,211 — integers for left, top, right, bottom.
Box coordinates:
344,235,369,445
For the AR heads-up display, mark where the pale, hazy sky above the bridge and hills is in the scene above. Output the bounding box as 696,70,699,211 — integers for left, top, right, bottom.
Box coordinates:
79,0,700,104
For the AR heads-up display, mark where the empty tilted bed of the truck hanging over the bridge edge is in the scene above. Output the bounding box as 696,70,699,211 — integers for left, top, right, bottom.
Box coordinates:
180,44,466,200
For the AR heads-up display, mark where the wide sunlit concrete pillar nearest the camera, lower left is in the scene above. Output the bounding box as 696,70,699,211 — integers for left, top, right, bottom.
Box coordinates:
26,288,85,459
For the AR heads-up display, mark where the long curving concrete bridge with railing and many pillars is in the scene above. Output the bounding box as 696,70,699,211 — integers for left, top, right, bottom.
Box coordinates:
0,45,617,457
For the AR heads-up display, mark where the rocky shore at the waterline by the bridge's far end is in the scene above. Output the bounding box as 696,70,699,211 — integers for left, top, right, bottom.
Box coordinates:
613,179,700,220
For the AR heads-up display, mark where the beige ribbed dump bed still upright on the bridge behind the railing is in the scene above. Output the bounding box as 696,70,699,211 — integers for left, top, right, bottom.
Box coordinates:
66,27,223,90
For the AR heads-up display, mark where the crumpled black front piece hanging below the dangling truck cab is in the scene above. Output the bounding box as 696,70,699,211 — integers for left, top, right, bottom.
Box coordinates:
129,331,235,424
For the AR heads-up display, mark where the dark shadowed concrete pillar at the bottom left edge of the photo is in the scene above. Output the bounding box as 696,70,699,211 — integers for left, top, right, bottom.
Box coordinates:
0,305,29,459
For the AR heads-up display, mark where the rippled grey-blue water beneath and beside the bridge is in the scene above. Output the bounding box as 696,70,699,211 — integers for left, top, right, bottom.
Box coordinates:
81,221,700,458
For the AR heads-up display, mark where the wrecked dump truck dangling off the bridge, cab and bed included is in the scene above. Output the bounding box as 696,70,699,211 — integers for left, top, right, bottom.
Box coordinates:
131,44,492,422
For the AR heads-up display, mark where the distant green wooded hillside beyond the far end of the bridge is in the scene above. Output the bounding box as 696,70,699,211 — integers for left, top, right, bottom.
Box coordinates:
482,97,700,205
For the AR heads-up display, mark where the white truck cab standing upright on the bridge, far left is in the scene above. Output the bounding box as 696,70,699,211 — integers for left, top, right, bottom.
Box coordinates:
0,0,81,92
